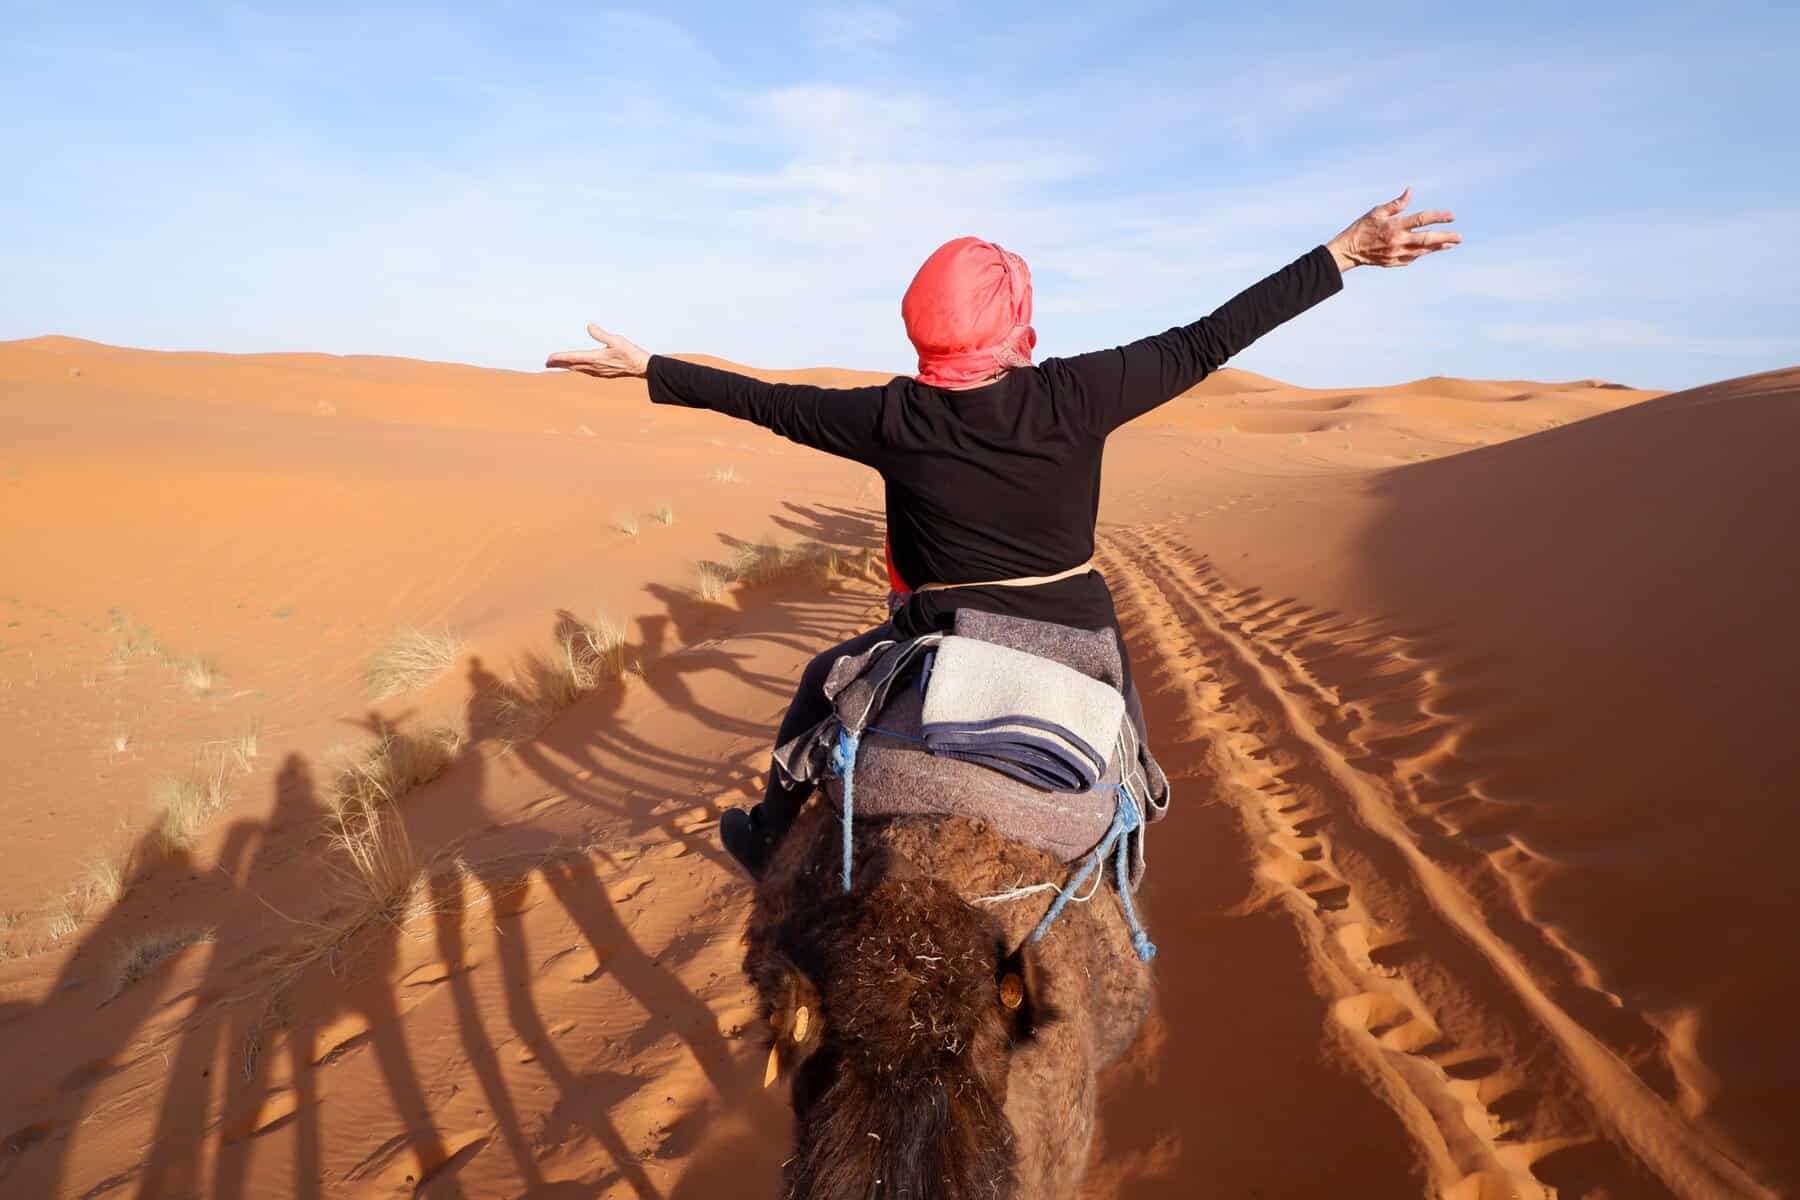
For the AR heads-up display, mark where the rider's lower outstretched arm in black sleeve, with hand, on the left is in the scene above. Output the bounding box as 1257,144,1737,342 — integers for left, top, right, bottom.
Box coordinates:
544,326,882,462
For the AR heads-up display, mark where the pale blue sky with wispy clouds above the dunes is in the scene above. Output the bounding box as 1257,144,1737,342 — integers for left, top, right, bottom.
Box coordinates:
0,0,1800,387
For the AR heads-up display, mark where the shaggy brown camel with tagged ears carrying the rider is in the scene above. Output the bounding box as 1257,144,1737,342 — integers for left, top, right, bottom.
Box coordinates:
743,799,1150,1200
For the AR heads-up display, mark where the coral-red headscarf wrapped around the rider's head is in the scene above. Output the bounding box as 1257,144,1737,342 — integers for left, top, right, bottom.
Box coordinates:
900,237,1037,387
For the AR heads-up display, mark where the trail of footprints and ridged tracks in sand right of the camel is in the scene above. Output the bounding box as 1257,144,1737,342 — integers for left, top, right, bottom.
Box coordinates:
1100,527,1768,1200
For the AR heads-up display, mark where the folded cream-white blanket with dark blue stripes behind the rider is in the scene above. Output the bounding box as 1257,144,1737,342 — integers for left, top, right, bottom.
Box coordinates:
920,637,1125,792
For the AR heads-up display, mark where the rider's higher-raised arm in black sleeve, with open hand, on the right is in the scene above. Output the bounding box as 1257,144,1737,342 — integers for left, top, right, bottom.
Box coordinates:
1062,189,1462,435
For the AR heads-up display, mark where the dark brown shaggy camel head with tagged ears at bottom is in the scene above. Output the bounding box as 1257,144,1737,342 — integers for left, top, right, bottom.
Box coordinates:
745,874,1049,1200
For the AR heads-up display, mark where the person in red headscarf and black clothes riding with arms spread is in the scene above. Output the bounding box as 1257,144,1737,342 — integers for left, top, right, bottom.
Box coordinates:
545,189,1462,878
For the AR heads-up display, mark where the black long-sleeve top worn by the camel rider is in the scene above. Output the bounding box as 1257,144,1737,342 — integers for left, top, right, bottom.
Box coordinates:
648,246,1343,637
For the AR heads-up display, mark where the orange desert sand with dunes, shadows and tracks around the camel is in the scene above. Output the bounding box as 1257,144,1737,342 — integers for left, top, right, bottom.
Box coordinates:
0,338,1800,1200
